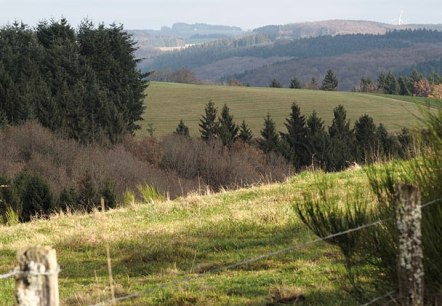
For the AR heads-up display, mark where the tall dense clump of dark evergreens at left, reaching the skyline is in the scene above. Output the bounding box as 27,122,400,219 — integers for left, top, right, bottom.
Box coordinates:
0,18,147,144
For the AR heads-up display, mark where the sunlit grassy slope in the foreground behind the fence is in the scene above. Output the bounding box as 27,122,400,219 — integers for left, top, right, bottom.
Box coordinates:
0,171,367,305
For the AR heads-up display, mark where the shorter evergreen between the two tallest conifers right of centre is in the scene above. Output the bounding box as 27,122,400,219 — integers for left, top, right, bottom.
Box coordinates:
307,111,328,166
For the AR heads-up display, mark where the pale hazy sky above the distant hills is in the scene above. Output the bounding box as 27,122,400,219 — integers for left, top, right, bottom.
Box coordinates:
0,0,442,30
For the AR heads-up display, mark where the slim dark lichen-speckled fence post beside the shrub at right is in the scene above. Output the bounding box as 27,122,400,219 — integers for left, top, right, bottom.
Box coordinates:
396,184,424,306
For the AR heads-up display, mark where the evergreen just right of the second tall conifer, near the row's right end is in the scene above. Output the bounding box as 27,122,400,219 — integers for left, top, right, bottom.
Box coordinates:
354,114,376,162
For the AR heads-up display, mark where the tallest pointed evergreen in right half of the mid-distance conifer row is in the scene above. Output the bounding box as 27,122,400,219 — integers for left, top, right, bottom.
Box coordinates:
281,102,310,170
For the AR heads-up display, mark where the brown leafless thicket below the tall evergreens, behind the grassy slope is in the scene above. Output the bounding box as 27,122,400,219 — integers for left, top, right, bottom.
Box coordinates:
0,122,289,200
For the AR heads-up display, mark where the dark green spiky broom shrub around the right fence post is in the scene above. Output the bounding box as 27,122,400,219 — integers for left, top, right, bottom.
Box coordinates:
294,101,442,304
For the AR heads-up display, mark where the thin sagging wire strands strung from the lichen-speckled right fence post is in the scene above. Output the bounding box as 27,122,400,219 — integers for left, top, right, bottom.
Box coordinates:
92,198,442,306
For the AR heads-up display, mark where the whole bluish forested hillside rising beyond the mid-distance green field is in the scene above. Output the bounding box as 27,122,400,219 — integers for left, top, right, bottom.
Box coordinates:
146,30,442,90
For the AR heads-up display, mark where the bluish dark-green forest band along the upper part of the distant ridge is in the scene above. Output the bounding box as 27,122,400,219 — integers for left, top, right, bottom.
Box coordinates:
152,29,442,69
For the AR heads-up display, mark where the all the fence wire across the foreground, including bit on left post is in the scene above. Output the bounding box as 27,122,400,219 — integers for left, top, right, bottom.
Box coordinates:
0,198,442,306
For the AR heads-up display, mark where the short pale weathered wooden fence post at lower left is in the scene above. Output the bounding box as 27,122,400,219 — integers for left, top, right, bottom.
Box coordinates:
15,247,59,306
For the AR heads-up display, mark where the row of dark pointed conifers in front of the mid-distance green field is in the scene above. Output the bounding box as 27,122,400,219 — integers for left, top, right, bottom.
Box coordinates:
174,101,413,171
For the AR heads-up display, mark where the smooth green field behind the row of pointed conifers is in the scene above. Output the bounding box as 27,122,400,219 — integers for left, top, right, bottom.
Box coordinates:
139,82,425,136
